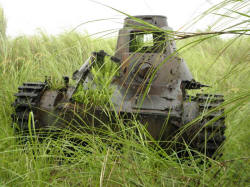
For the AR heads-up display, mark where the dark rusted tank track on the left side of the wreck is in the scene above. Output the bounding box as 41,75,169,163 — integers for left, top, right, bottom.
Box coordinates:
11,82,48,133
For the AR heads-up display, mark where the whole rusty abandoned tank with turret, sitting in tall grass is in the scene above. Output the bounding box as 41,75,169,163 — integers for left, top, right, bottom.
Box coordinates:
12,15,226,157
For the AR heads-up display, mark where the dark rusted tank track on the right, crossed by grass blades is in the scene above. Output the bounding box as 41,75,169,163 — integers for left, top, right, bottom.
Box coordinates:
188,94,226,158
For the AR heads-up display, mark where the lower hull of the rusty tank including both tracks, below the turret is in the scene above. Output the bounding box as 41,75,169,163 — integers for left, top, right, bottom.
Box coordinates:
12,83,225,157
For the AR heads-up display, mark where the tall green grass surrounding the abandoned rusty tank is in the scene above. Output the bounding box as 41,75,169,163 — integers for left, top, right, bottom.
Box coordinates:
0,1,250,186
